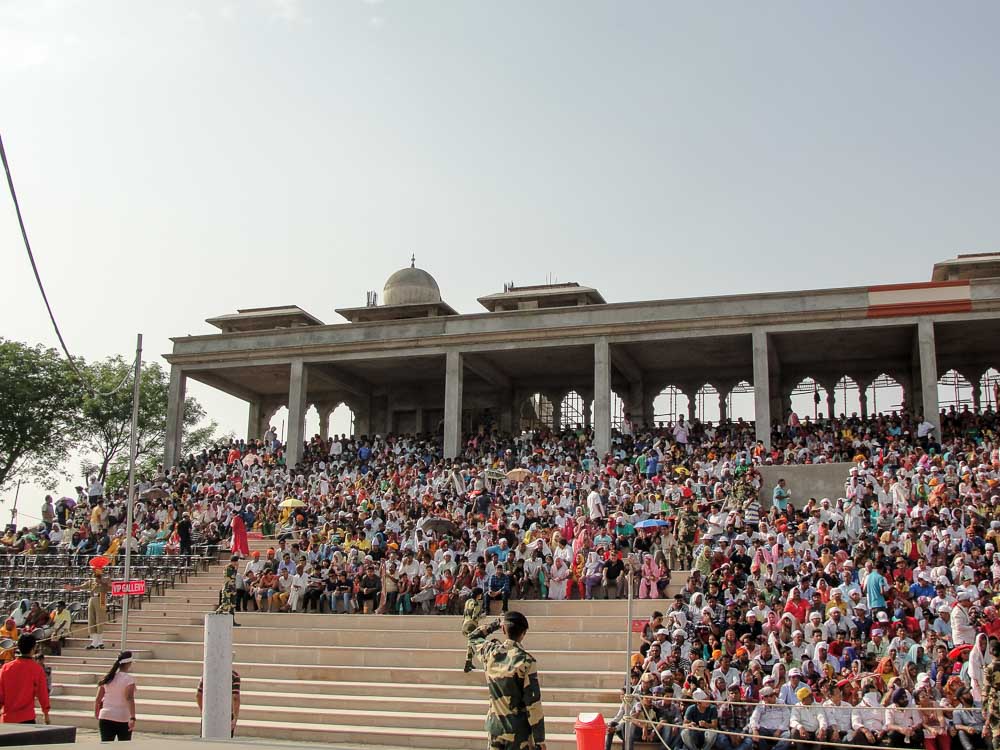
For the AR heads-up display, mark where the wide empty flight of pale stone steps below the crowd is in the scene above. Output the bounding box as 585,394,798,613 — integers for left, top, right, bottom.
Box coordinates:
47,541,686,750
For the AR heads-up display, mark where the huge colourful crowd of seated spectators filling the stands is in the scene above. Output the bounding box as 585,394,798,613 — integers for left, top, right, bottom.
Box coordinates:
0,409,1000,750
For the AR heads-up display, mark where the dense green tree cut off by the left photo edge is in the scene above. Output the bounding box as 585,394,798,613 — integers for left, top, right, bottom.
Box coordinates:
0,339,82,490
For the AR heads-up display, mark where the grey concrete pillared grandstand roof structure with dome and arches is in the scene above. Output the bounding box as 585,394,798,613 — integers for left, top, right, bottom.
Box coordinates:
165,253,1000,464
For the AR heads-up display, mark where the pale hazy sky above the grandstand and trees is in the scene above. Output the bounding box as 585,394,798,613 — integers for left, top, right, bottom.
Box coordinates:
0,0,1000,512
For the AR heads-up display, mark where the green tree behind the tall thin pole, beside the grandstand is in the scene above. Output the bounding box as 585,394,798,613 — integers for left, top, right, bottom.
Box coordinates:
81,357,217,489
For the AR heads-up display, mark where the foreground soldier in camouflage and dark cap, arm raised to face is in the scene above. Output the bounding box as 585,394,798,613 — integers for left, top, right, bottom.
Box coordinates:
469,612,545,750
